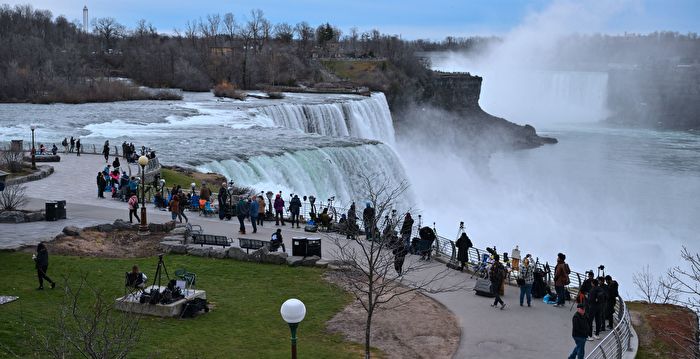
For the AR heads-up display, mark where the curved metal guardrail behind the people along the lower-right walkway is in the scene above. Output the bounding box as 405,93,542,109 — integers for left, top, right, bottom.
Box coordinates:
433,236,633,359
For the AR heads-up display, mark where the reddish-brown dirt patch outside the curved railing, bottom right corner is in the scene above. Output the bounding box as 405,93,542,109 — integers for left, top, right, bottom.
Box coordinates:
627,302,700,359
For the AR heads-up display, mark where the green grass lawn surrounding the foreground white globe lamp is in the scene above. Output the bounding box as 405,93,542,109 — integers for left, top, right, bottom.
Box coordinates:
0,252,362,358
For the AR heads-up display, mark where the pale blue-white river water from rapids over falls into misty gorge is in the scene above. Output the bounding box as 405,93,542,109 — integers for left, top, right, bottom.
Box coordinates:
0,89,700,295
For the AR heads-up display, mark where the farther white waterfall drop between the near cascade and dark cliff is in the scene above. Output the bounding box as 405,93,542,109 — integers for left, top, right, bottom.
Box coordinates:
258,92,394,146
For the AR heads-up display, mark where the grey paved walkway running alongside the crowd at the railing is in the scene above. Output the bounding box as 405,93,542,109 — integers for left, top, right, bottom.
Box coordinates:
0,156,580,358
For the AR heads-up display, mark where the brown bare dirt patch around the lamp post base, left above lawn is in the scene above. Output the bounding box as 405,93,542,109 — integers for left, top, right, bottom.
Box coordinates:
40,230,167,258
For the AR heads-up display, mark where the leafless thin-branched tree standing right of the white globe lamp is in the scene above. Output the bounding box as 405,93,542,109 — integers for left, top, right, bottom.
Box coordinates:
329,175,460,358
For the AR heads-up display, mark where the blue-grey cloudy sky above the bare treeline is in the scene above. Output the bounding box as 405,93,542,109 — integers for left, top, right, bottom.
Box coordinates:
5,0,700,39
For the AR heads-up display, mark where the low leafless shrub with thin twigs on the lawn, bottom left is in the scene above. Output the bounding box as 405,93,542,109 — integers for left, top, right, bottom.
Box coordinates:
28,275,141,359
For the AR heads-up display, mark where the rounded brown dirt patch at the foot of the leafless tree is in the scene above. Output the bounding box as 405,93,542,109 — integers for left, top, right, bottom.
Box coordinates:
325,271,461,358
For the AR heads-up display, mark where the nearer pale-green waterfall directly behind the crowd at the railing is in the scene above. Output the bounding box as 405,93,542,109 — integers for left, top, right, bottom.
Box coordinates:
197,144,413,208
